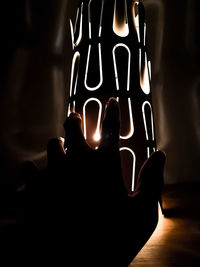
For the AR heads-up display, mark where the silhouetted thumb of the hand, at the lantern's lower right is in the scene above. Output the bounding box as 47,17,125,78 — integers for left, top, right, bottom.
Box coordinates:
135,151,166,198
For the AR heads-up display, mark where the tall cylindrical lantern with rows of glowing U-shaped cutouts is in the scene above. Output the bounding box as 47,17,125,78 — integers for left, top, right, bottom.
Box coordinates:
68,0,156,197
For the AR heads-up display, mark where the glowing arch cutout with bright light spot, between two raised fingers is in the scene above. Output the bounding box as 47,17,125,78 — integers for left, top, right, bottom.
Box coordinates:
83,97,102,141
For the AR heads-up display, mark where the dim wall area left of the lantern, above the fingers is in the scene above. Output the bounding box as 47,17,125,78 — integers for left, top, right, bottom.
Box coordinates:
0,0,71,188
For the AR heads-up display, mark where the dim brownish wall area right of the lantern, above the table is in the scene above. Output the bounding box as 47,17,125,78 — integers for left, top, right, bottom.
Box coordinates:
144,0,200,184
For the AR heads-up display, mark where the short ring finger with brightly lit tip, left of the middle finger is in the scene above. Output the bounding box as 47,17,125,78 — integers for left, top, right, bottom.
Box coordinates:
47,137,65,166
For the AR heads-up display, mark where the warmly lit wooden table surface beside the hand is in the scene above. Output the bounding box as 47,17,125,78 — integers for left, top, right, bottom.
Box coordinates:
129,185,200,267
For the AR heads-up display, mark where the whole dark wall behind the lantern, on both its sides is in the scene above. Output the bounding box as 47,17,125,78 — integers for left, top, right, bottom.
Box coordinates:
0,0,200,193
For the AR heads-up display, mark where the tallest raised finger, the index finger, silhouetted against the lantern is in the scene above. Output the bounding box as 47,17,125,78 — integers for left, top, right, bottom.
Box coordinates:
99,97,120,149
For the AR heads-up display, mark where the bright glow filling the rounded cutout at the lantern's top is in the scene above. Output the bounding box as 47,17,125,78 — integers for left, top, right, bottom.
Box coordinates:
113,0,129,37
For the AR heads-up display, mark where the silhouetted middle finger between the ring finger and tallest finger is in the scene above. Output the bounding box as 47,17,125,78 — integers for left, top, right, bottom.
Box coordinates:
64,112,88,151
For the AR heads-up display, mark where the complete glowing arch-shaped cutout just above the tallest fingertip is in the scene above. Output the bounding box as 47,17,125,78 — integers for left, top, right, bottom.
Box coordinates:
112,43,131,91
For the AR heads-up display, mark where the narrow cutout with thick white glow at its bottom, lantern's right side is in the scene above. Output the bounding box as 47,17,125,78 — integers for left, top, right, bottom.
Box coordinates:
139,49,150,95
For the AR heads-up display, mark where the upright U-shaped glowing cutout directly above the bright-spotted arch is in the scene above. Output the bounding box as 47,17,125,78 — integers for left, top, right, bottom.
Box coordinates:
84,43,103,91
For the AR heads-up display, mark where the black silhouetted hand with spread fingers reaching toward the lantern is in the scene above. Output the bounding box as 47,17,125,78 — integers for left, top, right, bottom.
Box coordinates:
25,98,165,266
